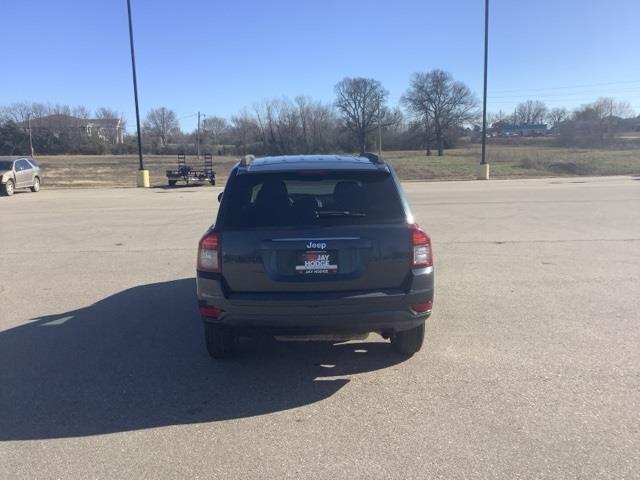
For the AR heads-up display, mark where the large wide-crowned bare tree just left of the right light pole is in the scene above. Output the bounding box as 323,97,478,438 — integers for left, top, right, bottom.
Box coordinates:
402,70,478,155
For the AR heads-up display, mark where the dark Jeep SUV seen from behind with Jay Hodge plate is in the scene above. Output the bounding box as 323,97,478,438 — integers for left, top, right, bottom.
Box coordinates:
197,154,433,358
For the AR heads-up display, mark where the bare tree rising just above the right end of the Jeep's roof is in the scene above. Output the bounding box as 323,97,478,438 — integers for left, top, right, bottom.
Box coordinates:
335,77,398,153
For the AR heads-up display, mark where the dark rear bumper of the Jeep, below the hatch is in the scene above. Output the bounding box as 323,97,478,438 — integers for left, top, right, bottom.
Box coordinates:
197,269,433,335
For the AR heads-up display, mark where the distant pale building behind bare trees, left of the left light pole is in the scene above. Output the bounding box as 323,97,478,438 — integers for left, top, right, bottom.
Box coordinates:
19,114,124,145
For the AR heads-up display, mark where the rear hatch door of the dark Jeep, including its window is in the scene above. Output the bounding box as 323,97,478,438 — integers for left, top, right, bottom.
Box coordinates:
220,170,410,293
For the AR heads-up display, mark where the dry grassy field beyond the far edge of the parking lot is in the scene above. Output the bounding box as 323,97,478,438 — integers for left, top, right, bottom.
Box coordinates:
37,145,640,187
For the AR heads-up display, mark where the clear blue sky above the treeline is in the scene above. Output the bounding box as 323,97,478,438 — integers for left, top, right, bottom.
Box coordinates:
0,0,640,130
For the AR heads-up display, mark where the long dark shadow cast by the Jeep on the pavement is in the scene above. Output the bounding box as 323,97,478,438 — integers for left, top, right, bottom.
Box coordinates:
0,278,403,441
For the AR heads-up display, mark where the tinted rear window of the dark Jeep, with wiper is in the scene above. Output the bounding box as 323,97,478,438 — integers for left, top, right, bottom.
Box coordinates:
222,171,406,229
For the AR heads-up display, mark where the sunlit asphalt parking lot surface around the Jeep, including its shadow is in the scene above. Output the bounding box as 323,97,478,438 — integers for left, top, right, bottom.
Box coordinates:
0,177,640,479
